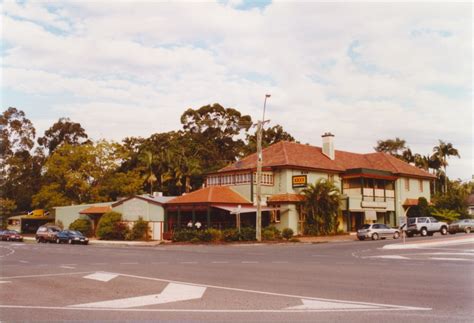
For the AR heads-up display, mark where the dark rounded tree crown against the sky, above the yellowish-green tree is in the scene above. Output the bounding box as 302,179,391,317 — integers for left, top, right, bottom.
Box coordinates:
38,118,90,154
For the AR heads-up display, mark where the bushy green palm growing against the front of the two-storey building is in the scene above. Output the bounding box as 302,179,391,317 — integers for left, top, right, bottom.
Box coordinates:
301,178,341,234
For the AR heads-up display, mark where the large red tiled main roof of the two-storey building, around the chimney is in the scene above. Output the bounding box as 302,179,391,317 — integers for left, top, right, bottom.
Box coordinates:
219,141,435,178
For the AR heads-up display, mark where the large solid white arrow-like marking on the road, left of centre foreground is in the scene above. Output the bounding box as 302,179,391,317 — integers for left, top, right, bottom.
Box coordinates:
71,283,206,308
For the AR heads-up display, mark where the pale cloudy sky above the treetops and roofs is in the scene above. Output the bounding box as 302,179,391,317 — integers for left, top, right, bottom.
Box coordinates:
0,0,474,180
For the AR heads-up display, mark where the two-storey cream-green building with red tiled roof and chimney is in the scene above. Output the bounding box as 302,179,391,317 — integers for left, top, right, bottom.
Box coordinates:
206,133,435,233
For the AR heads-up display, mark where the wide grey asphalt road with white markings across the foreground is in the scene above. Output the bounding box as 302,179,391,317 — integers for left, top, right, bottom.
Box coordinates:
0,235,474,322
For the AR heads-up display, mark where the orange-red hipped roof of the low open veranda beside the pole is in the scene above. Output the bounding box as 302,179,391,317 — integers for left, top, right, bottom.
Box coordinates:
166,186,251,205
